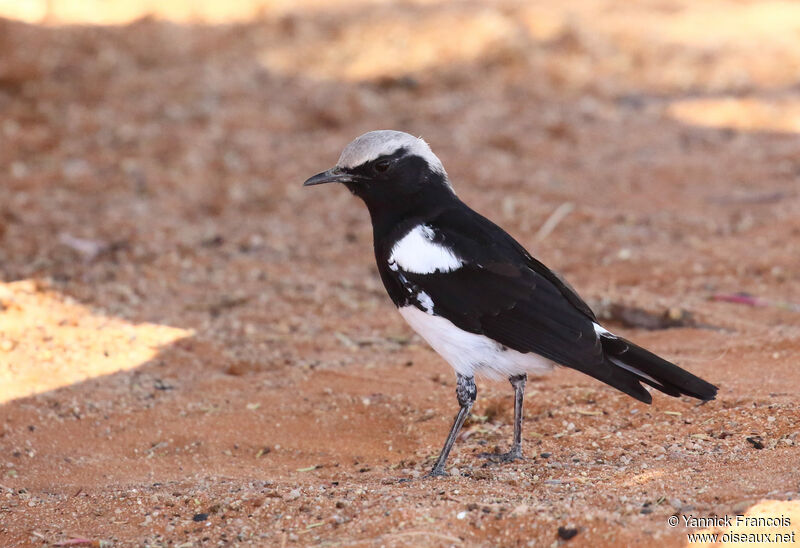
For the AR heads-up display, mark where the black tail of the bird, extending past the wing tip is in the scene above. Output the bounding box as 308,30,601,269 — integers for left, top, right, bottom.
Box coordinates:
598,332,717,403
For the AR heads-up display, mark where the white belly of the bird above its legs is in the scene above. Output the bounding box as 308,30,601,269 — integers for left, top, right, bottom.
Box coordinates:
398,306,555,379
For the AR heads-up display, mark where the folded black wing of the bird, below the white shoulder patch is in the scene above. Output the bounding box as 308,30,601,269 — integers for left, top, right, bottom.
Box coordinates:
381,206,651,402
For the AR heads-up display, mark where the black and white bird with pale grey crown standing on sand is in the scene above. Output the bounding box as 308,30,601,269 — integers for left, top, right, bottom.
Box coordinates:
303,130,717,477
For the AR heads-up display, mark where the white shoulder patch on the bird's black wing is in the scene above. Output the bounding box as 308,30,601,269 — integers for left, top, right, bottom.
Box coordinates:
389,225,464,274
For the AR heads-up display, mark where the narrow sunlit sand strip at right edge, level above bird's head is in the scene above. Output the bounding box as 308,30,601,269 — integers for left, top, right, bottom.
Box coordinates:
669,97,800,132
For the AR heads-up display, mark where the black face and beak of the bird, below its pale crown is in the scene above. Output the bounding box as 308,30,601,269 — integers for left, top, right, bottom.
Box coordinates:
304,148,452,217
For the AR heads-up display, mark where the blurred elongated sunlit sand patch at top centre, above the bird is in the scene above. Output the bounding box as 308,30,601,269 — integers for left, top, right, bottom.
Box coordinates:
260,9,519,81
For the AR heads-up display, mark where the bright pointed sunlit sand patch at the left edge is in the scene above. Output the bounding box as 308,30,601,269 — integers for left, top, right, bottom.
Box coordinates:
0,280,193,402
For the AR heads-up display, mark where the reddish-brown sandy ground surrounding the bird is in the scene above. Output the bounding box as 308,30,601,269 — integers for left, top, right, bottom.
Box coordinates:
0,0,800,547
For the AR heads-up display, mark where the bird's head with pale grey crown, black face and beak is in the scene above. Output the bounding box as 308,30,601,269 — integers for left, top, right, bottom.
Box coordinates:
303,130,453,210
